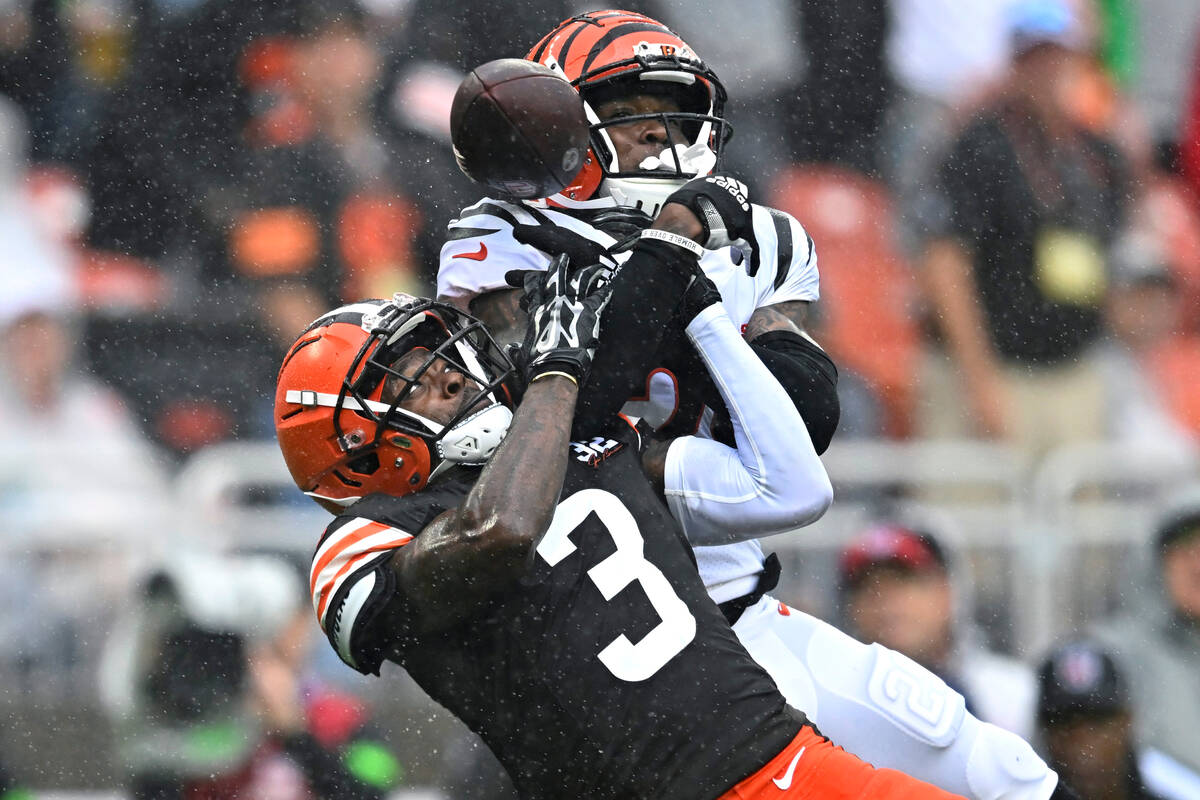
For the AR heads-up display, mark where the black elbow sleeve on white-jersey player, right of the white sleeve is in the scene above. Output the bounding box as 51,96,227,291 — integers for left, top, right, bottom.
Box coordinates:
712,331,841,455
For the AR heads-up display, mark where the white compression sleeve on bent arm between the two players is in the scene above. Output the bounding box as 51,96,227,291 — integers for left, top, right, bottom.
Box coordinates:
664,305,833,545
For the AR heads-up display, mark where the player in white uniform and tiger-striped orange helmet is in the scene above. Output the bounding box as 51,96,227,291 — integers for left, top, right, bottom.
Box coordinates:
438,11,1057,800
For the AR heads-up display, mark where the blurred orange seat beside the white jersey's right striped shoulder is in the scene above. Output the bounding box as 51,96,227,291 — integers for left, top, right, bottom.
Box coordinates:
767,166,920,437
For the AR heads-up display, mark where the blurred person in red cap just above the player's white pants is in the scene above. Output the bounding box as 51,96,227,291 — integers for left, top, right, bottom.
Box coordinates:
839,524,1036,738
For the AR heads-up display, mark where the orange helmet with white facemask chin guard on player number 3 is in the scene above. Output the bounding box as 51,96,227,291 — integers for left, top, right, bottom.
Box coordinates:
275,294,515,513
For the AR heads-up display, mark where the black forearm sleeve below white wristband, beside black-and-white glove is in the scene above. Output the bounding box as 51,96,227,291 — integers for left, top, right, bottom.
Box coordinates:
572,239,700,437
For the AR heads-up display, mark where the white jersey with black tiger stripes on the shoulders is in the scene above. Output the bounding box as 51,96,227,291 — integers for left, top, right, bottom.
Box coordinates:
438,198,820,603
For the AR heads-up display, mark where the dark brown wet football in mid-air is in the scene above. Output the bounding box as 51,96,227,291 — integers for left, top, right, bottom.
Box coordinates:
450,59,588,199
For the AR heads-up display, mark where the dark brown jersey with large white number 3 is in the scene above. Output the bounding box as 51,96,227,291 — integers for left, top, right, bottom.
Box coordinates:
312,431,804,800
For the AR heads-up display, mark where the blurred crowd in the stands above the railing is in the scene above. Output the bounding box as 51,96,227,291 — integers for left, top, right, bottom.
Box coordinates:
0,0,1200,458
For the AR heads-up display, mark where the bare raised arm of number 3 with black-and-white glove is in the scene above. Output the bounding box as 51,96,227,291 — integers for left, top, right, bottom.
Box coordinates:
392,257,610,632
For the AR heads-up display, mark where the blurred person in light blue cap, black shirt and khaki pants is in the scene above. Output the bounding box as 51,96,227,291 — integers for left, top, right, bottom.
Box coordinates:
917,0,1127,457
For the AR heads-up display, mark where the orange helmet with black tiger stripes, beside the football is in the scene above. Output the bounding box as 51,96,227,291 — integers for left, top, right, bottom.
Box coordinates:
526,10,733,216
